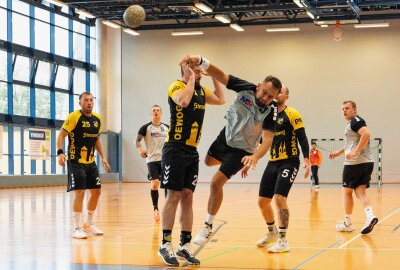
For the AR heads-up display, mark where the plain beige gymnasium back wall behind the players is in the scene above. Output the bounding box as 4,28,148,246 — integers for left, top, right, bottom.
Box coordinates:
117,21,400,183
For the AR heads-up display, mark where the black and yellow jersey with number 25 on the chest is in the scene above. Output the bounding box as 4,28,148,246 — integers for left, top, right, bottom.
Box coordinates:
62,110,101,164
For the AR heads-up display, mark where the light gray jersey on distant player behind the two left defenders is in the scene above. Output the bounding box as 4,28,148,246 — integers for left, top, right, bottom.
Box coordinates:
138,122,169,163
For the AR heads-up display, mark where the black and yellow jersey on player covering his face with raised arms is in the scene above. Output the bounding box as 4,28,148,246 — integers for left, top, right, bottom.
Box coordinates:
165,81,212,147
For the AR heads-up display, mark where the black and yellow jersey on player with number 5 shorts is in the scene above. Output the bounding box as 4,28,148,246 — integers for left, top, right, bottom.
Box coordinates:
269,107,308,161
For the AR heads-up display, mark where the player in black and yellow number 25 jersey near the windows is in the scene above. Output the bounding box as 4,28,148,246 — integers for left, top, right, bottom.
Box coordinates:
57,92,110,239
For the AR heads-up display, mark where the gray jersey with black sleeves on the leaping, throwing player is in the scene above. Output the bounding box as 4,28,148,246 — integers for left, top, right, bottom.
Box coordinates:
225,75,277,153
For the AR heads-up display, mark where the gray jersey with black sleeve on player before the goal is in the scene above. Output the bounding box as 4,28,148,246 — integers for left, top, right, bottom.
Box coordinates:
344,115,374,165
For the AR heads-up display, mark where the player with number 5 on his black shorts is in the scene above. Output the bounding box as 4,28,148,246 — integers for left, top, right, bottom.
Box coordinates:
253,86,310,253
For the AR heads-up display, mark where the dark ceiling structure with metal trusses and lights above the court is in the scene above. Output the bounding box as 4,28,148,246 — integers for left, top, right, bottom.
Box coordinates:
62,0,400,30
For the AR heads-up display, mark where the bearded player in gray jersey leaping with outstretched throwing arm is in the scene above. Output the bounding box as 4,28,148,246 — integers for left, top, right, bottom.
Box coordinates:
177,55,282,245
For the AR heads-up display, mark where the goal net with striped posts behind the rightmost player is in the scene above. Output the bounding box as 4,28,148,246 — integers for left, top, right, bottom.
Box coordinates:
311,138,382,185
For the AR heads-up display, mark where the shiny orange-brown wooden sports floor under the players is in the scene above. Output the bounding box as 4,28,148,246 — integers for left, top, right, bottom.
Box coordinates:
0,183,400,270
